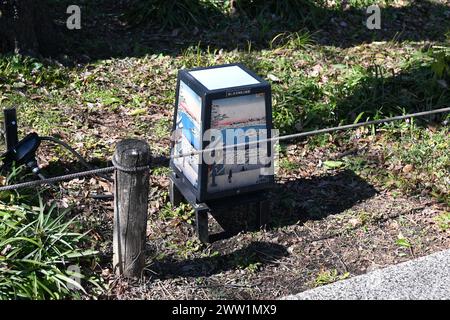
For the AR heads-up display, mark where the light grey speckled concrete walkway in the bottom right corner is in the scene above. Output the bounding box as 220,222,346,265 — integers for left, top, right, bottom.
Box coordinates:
282,249,450,300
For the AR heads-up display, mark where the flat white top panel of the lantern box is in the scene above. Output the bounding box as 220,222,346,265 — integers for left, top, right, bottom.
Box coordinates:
189,66,260,90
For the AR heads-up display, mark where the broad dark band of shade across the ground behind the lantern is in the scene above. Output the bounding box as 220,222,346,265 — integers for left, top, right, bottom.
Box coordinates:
43,0,448,61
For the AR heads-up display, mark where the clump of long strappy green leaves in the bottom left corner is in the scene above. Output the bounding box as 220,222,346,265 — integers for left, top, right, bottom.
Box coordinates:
0,201,102,300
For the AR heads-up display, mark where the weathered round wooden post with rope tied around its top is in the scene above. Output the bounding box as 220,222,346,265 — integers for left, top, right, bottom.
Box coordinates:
113,139,151,277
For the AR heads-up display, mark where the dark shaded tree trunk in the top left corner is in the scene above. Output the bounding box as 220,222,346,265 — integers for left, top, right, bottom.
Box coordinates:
0,0,59,56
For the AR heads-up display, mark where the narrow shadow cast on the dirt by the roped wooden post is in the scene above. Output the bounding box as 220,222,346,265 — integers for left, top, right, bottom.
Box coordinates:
147,241,288,279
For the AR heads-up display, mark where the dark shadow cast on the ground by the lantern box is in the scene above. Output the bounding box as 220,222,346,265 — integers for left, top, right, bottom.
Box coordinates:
210,170,377,242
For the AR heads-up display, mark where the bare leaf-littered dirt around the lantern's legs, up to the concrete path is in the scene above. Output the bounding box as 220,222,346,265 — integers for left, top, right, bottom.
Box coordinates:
59,121,450,299
